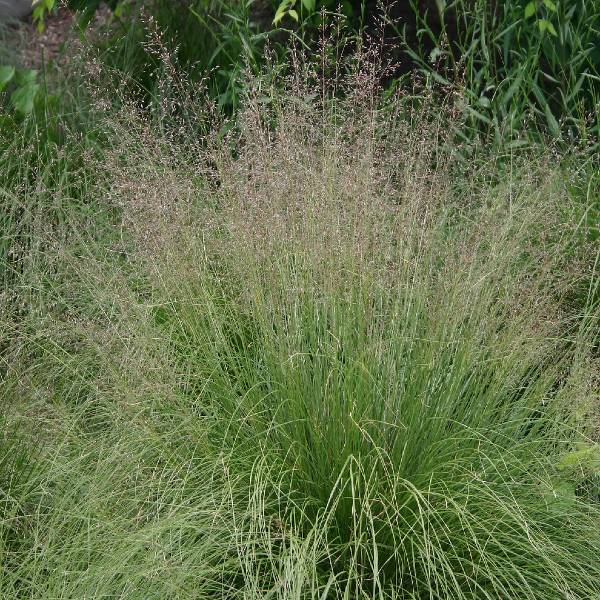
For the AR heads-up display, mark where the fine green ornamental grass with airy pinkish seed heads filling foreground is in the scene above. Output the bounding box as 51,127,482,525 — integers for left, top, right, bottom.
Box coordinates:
0,43,600,600
